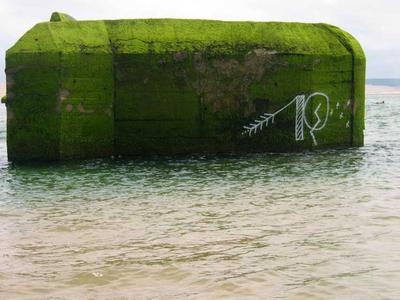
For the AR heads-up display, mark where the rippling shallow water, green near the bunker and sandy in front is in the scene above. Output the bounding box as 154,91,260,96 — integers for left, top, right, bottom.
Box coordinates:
0,95,400,299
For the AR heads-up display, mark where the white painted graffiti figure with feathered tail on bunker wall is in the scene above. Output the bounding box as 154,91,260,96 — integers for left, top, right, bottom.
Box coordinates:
243,92,329,145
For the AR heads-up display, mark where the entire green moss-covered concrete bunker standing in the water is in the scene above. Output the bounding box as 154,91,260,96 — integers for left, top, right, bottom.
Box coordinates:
6,13,365,160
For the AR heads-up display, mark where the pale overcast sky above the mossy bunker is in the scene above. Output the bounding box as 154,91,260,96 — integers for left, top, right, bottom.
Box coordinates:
0,0,400,82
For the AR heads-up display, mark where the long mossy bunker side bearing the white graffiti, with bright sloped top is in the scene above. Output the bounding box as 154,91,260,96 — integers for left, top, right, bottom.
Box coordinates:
107,20,360,155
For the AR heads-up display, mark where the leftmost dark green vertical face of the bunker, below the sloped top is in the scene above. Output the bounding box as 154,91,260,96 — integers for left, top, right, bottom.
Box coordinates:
6,52,60,161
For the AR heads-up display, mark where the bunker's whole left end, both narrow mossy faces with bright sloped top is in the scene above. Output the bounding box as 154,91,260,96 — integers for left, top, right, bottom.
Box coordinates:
7,21,114,160
